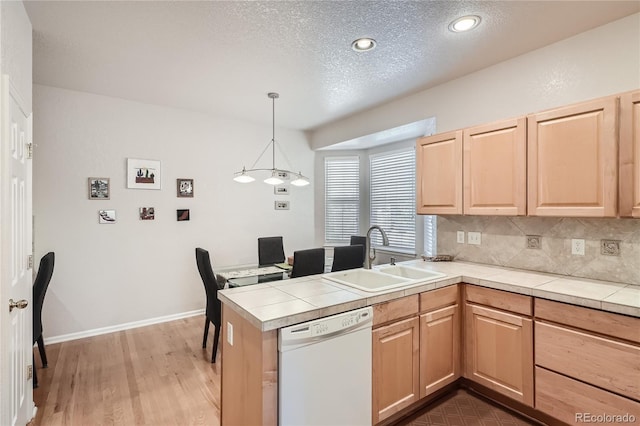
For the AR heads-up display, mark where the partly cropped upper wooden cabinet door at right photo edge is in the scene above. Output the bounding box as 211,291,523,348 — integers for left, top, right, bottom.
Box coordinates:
619,90,640,217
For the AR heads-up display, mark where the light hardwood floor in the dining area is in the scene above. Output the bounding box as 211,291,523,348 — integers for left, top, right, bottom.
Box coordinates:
29,316,222,426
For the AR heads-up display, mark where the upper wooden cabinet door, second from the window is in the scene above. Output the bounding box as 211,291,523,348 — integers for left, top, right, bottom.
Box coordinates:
463,117,527,216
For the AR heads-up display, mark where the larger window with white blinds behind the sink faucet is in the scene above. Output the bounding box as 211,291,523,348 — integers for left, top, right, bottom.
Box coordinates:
369,148,416,253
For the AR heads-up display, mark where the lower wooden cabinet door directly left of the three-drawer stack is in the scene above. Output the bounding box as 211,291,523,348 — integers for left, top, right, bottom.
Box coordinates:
465,304,533,406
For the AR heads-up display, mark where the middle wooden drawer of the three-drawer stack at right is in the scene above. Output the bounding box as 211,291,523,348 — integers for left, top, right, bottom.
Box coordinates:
535,322,640,400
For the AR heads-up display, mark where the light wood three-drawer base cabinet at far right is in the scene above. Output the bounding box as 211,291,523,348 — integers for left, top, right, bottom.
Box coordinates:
535,298,640,424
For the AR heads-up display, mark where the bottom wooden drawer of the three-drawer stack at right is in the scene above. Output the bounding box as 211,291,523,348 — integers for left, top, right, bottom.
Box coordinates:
536,367,640,424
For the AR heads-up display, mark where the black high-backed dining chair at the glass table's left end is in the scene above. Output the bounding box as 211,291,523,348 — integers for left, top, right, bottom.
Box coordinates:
196,247,222,363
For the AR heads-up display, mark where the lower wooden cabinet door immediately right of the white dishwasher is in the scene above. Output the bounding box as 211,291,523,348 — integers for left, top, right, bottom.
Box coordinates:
372,317,420,424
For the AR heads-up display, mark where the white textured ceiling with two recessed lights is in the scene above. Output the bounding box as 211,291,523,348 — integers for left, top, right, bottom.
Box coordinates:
25,0,640,130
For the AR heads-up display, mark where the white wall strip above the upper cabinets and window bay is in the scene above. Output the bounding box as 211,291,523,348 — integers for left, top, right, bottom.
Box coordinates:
311,14,640,149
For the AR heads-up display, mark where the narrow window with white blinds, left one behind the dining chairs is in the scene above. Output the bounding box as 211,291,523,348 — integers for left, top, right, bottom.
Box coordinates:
324,157,360,244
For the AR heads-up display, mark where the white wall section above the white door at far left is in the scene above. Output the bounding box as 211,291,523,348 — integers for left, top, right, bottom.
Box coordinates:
0,1,33,112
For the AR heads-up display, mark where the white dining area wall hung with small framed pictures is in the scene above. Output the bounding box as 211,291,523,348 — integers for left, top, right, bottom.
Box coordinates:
33,85,314,339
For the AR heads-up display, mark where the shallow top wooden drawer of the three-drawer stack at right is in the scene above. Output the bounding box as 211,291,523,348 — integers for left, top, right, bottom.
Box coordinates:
535,299,640,343
